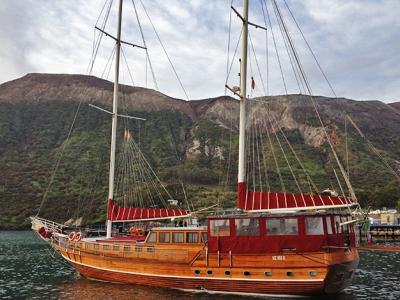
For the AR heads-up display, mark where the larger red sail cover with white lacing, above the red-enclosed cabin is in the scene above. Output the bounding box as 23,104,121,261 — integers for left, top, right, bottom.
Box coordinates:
237,182,357,212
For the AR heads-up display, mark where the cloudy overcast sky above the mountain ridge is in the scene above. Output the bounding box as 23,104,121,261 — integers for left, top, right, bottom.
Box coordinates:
0,0,400,102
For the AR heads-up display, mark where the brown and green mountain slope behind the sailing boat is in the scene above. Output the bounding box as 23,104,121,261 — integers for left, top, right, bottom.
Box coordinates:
0,74,400,228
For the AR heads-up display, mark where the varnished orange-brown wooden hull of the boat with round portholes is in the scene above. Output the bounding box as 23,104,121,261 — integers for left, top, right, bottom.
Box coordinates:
53,243,358,295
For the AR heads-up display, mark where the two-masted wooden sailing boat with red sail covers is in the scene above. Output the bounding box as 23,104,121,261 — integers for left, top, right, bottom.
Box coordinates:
32,0,359,295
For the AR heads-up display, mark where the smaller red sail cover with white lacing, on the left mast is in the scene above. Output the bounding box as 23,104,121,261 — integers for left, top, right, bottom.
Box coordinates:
107,200,190,221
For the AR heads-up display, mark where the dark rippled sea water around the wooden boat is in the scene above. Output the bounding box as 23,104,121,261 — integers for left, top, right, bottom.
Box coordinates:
0,231,400,300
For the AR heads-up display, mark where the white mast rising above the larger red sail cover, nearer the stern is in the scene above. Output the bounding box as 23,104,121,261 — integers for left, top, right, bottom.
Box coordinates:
238,0,249,184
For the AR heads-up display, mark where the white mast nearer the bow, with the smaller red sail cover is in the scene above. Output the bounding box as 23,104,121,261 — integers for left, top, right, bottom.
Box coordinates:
107,0,123,238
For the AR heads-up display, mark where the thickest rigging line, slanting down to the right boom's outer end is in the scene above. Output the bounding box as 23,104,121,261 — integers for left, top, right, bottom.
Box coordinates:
272,0,357,201
